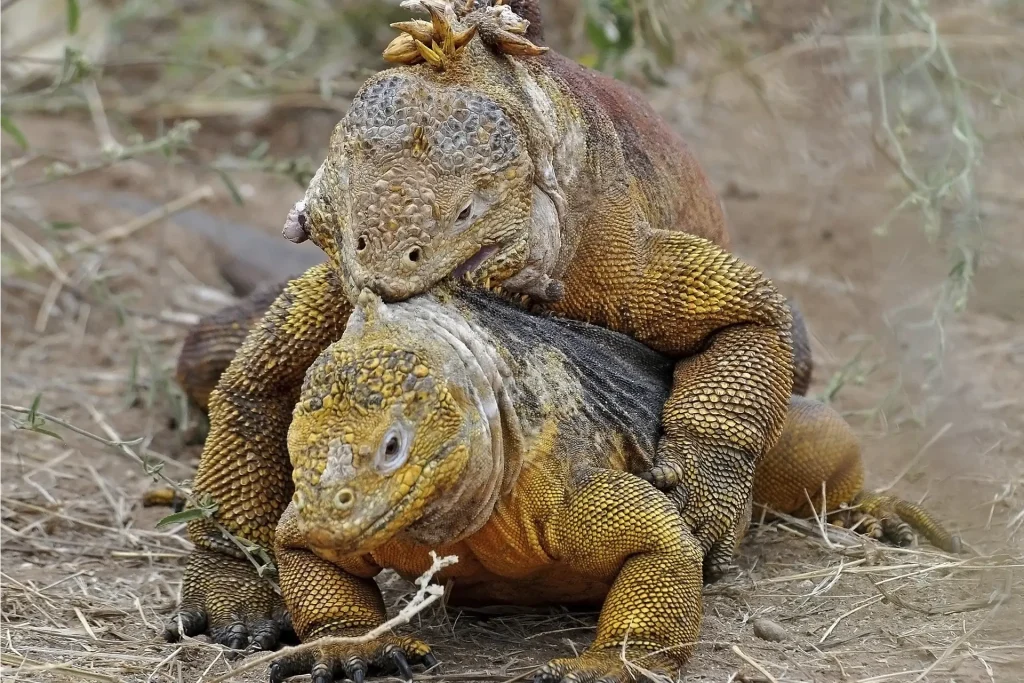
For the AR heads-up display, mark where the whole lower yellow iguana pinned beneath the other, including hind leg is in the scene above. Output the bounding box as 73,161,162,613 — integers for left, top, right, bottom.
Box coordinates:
251,286,956,683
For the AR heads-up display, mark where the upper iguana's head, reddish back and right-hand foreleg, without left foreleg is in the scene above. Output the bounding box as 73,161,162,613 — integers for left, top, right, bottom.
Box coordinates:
287,0,793,575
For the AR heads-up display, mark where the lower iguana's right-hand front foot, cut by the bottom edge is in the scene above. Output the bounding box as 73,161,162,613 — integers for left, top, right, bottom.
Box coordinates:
534,647,678,683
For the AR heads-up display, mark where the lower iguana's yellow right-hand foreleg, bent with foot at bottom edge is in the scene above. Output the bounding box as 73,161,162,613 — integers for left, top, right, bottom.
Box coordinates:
535,469,703,683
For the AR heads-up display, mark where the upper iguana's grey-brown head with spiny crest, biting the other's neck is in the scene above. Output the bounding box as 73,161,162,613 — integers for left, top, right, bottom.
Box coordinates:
286,0,554,301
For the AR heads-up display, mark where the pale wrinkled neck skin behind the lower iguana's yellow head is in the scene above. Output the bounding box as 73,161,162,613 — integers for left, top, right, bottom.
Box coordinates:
345,295,523,546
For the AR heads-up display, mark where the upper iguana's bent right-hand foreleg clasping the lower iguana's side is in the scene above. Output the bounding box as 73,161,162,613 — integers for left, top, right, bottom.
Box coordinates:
553,227,794,578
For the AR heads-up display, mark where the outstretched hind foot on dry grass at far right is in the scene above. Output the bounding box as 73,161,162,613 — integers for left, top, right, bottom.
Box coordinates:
829,493,962,554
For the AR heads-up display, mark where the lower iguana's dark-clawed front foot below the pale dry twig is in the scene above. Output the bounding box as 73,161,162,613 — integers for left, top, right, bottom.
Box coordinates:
270,633,437,683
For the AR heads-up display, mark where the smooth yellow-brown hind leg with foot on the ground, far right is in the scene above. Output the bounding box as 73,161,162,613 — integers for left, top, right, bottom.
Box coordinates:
754,396,961,553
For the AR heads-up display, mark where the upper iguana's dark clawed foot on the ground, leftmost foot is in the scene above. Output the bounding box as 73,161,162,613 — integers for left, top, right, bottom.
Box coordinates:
164,548,291,650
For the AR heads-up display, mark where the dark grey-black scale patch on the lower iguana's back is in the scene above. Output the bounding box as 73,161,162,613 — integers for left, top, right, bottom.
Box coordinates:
458,287,675,457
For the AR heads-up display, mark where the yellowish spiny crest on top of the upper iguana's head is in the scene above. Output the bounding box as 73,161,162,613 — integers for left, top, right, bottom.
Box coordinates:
384,0,548,70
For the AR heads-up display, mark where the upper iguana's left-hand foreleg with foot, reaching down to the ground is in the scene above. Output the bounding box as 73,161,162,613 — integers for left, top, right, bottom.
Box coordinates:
167,264,350,647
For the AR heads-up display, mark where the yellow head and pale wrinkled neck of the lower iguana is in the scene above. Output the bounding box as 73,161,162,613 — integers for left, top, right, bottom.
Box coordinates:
288,292,518,554
